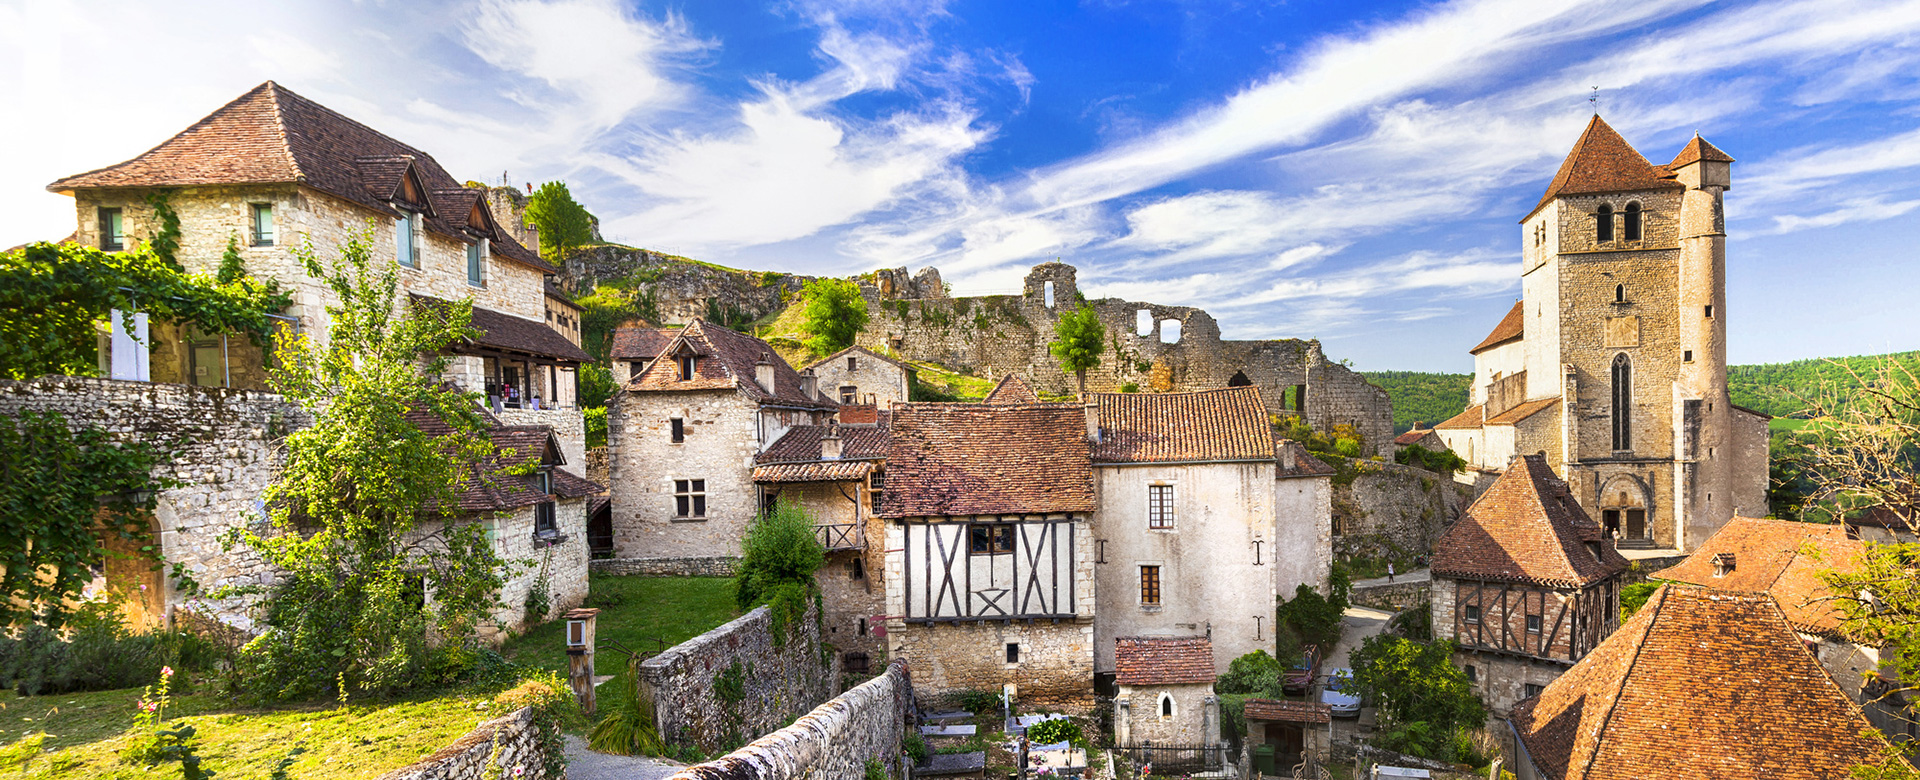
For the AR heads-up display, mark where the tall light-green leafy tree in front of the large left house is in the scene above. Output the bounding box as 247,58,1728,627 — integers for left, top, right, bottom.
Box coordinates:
230,229,511,697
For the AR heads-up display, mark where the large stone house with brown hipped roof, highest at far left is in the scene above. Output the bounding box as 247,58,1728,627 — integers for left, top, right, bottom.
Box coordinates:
48,81,588,427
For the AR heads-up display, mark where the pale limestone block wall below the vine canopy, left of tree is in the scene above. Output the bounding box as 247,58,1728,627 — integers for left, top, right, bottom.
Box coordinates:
0,377,311,628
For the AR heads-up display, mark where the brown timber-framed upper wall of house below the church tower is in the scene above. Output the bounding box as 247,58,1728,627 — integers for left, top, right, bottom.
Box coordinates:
1448,574,1620,665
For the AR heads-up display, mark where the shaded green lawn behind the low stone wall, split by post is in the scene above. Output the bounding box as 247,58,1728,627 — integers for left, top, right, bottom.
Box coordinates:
501,576,739,674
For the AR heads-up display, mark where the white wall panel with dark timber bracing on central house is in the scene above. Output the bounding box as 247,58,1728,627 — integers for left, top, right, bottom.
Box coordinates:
895,515,1083,624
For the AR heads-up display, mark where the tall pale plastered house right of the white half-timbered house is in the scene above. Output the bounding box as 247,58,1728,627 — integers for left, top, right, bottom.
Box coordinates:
1085,386,1332,674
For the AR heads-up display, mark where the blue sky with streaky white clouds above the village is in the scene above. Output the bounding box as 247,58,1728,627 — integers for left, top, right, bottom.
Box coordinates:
0,0,1920,371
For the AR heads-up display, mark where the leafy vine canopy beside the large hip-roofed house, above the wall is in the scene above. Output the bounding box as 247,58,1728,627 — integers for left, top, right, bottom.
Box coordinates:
0,242,290,378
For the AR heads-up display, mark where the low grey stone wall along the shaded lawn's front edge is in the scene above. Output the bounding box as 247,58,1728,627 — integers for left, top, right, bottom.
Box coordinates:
639,607,839,753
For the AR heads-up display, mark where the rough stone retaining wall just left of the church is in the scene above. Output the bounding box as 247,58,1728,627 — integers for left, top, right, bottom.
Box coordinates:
1332,461,1473,557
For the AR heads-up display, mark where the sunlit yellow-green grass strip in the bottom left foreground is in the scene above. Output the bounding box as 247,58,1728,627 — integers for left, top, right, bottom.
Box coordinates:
0,688,505,780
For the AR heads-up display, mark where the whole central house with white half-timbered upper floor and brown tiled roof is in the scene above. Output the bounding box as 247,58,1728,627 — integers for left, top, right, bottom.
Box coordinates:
879,403,1094,713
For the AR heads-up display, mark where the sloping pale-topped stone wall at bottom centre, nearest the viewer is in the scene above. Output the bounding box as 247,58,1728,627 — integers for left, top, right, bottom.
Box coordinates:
672,661,918,780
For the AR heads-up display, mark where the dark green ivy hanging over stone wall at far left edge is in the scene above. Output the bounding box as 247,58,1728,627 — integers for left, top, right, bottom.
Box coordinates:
0,411,165,626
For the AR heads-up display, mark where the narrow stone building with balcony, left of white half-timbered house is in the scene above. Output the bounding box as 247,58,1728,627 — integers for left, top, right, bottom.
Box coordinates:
753,405,891,674
